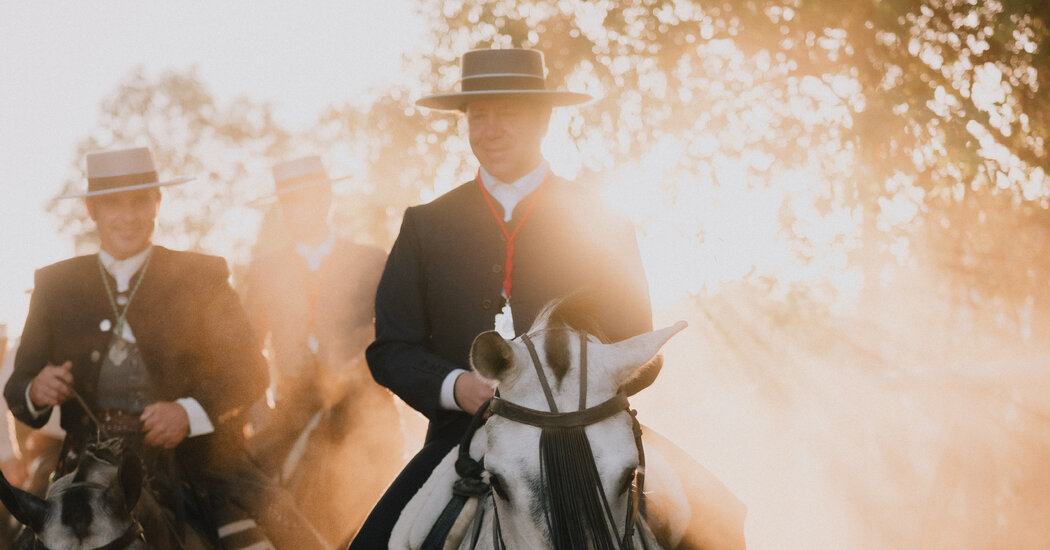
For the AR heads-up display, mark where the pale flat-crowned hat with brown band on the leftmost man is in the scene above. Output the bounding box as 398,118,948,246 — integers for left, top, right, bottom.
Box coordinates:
58,147,193,198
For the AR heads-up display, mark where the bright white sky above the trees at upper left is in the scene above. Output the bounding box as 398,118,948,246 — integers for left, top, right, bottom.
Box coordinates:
0,0,423,335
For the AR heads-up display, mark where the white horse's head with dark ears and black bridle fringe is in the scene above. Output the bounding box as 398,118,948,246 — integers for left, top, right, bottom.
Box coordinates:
470,302,686,549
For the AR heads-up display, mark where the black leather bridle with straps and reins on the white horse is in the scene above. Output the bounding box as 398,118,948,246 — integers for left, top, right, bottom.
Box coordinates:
421,332,648,550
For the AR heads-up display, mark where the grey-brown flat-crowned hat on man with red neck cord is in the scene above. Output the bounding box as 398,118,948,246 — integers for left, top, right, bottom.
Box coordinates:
416,48,592,111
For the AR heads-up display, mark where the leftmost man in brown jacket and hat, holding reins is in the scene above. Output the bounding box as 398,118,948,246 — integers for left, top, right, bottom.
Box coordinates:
4,147,327,547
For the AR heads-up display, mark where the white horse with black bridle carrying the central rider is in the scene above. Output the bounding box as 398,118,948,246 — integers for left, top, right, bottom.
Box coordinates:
390,302,689,550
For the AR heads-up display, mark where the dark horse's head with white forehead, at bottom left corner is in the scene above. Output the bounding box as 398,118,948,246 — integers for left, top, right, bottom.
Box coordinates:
0,440,143,550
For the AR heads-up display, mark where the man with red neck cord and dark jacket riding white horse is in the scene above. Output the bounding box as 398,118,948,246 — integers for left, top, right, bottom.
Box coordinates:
352,49,652,548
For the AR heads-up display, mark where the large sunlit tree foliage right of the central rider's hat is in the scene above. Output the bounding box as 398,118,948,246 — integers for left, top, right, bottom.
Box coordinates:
377,0,1050,333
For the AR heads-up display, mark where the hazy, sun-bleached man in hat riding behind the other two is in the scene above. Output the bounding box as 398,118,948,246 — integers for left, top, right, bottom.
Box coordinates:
245,155,404,541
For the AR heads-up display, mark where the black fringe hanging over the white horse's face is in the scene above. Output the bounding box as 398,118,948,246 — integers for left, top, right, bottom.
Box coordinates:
540,426,620,550
